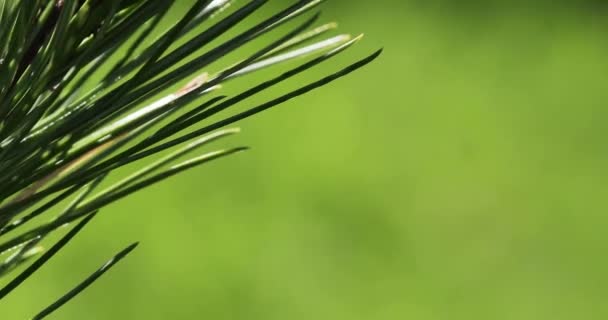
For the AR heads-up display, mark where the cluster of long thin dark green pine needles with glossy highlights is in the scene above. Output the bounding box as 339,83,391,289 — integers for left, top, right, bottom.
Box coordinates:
0,0,381,319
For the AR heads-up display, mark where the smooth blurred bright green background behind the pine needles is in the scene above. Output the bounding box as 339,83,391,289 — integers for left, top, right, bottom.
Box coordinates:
7,0,608,320
